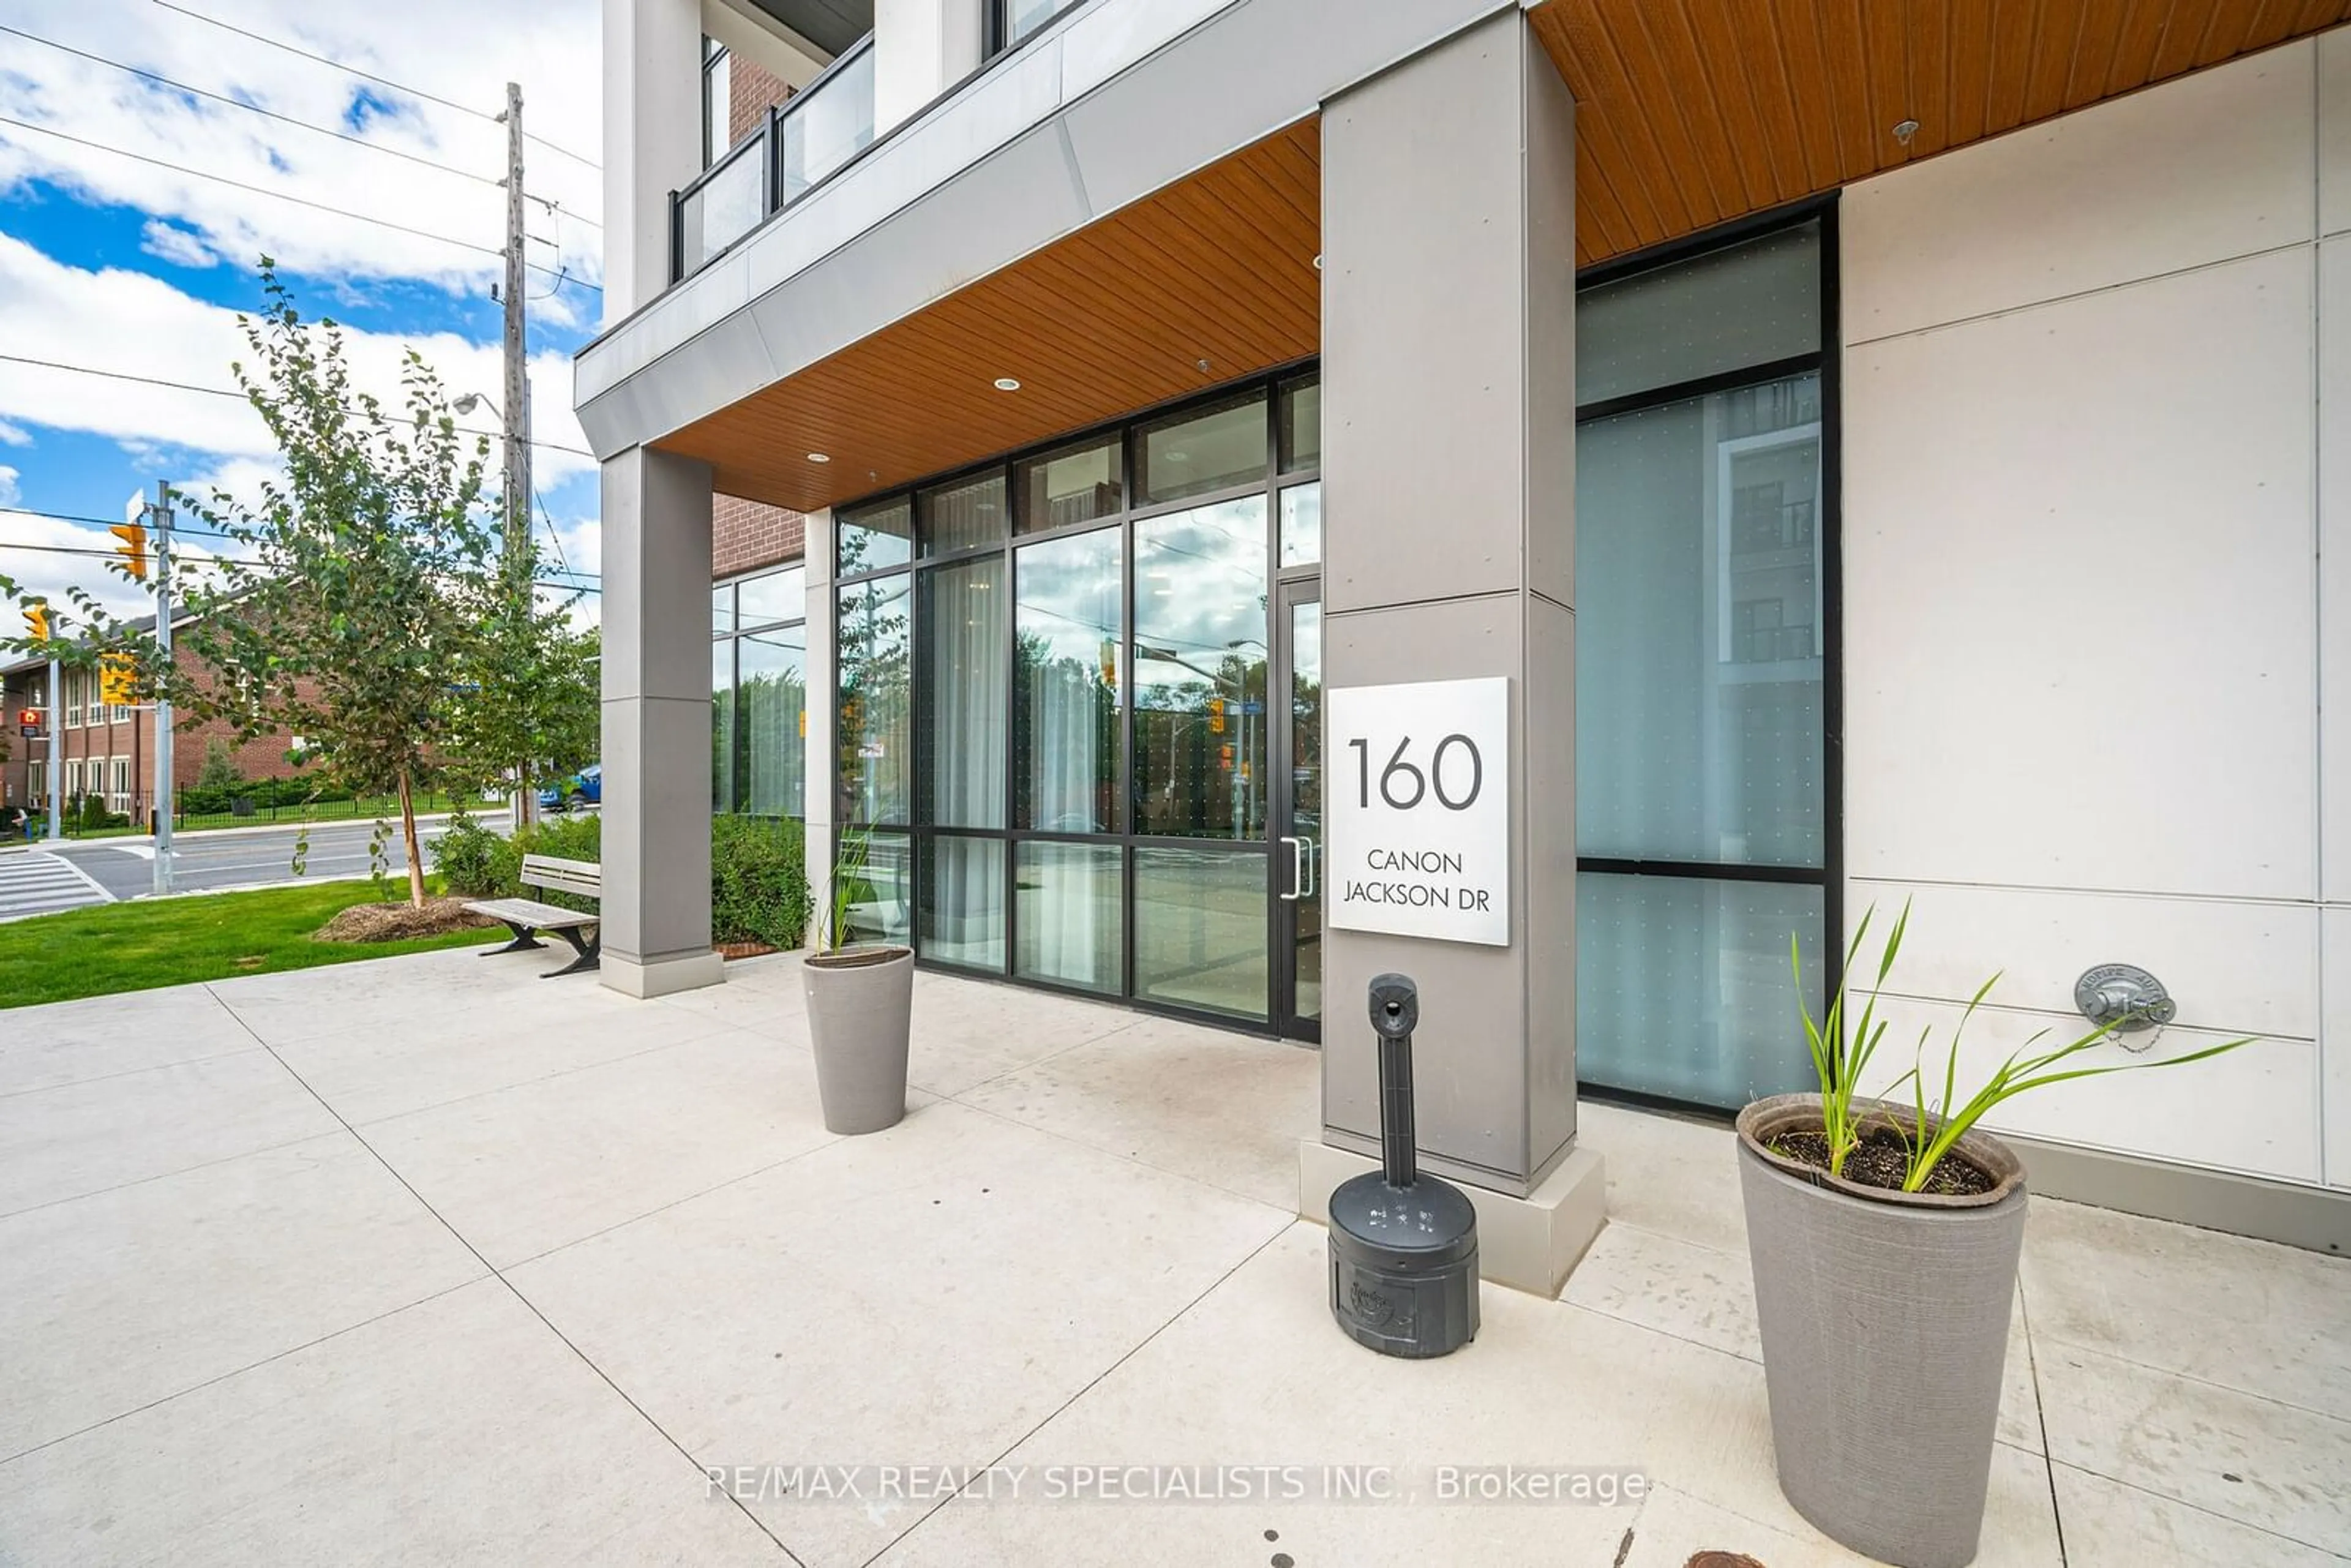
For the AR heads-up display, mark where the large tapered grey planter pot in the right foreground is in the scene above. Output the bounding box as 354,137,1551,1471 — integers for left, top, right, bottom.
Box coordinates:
1740,1093,2024,1568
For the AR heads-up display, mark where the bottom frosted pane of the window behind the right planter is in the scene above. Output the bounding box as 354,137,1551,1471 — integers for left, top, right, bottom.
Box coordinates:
1575,872,1824,1109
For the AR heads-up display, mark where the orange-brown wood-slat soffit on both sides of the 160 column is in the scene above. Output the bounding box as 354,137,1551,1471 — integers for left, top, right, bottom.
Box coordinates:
658,0,2351,510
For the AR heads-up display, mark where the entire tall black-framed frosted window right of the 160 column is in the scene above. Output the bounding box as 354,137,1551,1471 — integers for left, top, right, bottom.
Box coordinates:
1575,216,1839,1107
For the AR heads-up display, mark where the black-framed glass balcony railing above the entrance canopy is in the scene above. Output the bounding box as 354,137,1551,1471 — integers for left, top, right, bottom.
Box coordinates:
670,33,874,282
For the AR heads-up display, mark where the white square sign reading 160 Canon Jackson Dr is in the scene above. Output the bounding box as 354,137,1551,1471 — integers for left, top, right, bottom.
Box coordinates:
1324,675,1509,947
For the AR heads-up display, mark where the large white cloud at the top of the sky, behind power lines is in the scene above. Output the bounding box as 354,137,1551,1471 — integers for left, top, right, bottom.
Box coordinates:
0,0,602,301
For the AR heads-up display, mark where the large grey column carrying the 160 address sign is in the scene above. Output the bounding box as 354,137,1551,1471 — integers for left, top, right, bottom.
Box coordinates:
1321,9,1599,1203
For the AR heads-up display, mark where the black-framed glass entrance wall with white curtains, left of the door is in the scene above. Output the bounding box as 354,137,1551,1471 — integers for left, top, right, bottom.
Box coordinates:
834,373,1321,1020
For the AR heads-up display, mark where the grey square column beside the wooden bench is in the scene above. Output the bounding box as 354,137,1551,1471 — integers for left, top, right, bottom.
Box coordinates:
602,447,724,997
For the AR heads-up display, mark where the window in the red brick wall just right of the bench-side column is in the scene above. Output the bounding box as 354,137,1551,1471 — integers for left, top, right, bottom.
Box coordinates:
710,566,809,820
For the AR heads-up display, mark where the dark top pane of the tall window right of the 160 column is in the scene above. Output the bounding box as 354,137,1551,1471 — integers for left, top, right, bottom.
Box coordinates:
1575,223,1820,413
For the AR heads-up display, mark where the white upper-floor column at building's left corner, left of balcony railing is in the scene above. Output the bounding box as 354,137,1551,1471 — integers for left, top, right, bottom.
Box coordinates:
604,0,703,327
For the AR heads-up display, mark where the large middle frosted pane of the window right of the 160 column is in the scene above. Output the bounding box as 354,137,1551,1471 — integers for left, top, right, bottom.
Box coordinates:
1575,376,1827,868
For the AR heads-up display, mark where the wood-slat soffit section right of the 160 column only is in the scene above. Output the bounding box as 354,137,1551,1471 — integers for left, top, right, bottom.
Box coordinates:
1528,0,2351,266
